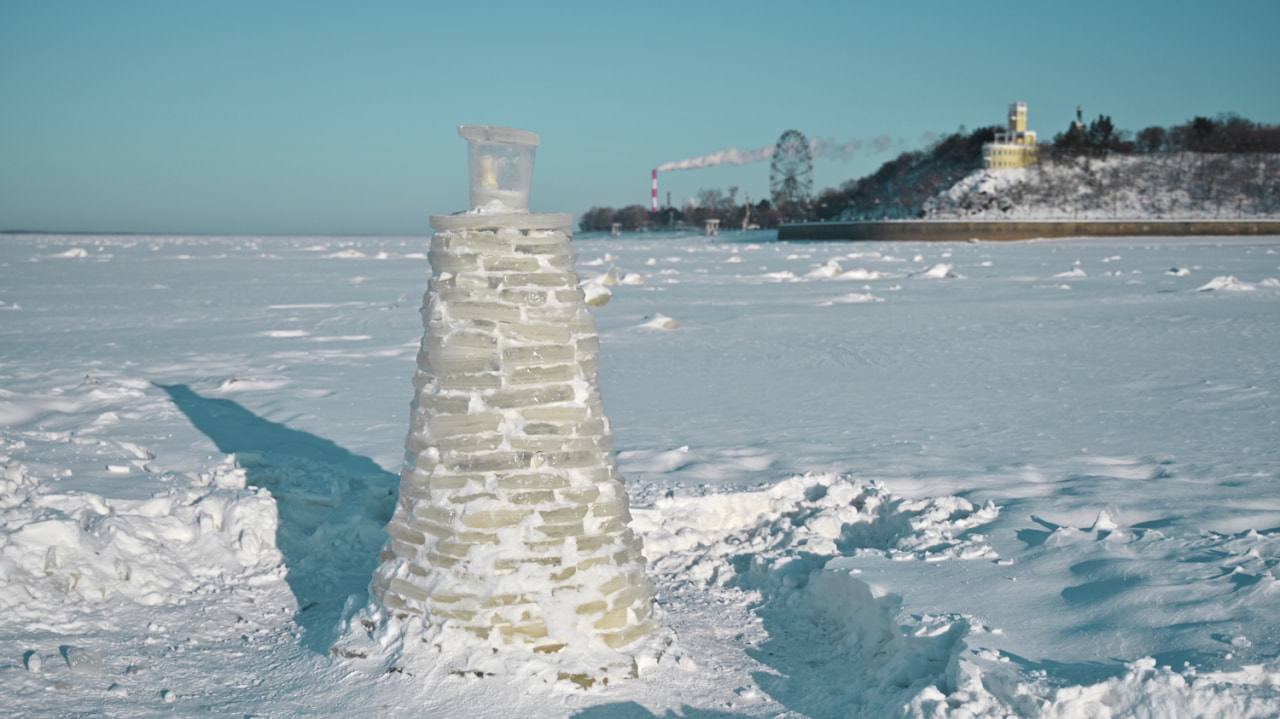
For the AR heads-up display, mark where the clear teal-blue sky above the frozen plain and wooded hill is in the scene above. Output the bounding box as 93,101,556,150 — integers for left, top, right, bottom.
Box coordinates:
0,0,1280,234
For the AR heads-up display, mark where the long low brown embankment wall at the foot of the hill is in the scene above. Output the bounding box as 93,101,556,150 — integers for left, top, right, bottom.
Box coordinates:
778,219,1280,242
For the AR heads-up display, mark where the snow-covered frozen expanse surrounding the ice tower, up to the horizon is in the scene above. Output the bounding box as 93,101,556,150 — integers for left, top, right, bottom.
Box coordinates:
0,233,1280,718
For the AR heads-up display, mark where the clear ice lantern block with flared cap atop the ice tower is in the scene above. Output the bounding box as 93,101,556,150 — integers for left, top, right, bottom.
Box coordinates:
458,125,539,212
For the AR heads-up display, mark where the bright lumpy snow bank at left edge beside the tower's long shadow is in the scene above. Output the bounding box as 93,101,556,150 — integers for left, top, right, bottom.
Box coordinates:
0,459,283,608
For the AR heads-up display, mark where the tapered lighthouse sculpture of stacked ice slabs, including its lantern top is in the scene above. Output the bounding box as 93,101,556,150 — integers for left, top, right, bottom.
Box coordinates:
372,125,654,683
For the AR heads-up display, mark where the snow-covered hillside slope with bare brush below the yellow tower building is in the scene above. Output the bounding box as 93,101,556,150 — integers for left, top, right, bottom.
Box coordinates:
922,152,1280,219
